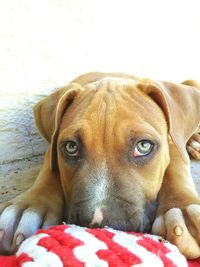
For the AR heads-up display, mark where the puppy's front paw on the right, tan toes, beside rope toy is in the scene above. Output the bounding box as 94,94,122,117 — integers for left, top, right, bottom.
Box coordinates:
152,204,200,259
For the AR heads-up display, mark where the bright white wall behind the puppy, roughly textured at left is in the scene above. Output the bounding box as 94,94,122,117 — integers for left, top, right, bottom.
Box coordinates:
0,0,200,200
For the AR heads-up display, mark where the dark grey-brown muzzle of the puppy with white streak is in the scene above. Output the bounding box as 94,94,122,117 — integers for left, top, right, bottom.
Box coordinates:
66,164,157,232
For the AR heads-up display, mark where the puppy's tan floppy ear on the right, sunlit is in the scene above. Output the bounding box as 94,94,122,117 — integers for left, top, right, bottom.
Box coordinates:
138,79,200,161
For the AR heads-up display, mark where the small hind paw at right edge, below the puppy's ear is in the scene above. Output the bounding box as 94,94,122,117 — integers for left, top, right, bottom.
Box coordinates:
187,133,200,160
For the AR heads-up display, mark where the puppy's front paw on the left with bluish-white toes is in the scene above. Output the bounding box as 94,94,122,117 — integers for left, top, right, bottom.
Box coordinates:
0,192,62,254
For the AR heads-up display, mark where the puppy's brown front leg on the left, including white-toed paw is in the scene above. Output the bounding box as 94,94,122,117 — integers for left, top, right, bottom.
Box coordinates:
0,149,64,253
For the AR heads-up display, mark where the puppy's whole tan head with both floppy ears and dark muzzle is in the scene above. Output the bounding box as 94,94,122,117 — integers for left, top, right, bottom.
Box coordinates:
34,74,199,231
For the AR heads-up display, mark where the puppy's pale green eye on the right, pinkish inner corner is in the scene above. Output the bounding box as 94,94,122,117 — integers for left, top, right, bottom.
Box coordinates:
133,140,154,158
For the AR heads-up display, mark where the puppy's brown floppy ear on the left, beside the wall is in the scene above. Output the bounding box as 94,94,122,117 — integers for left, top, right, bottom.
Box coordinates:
33,83,82,170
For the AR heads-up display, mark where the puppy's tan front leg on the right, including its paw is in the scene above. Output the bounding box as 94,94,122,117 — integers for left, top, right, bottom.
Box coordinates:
152,145,200,259
